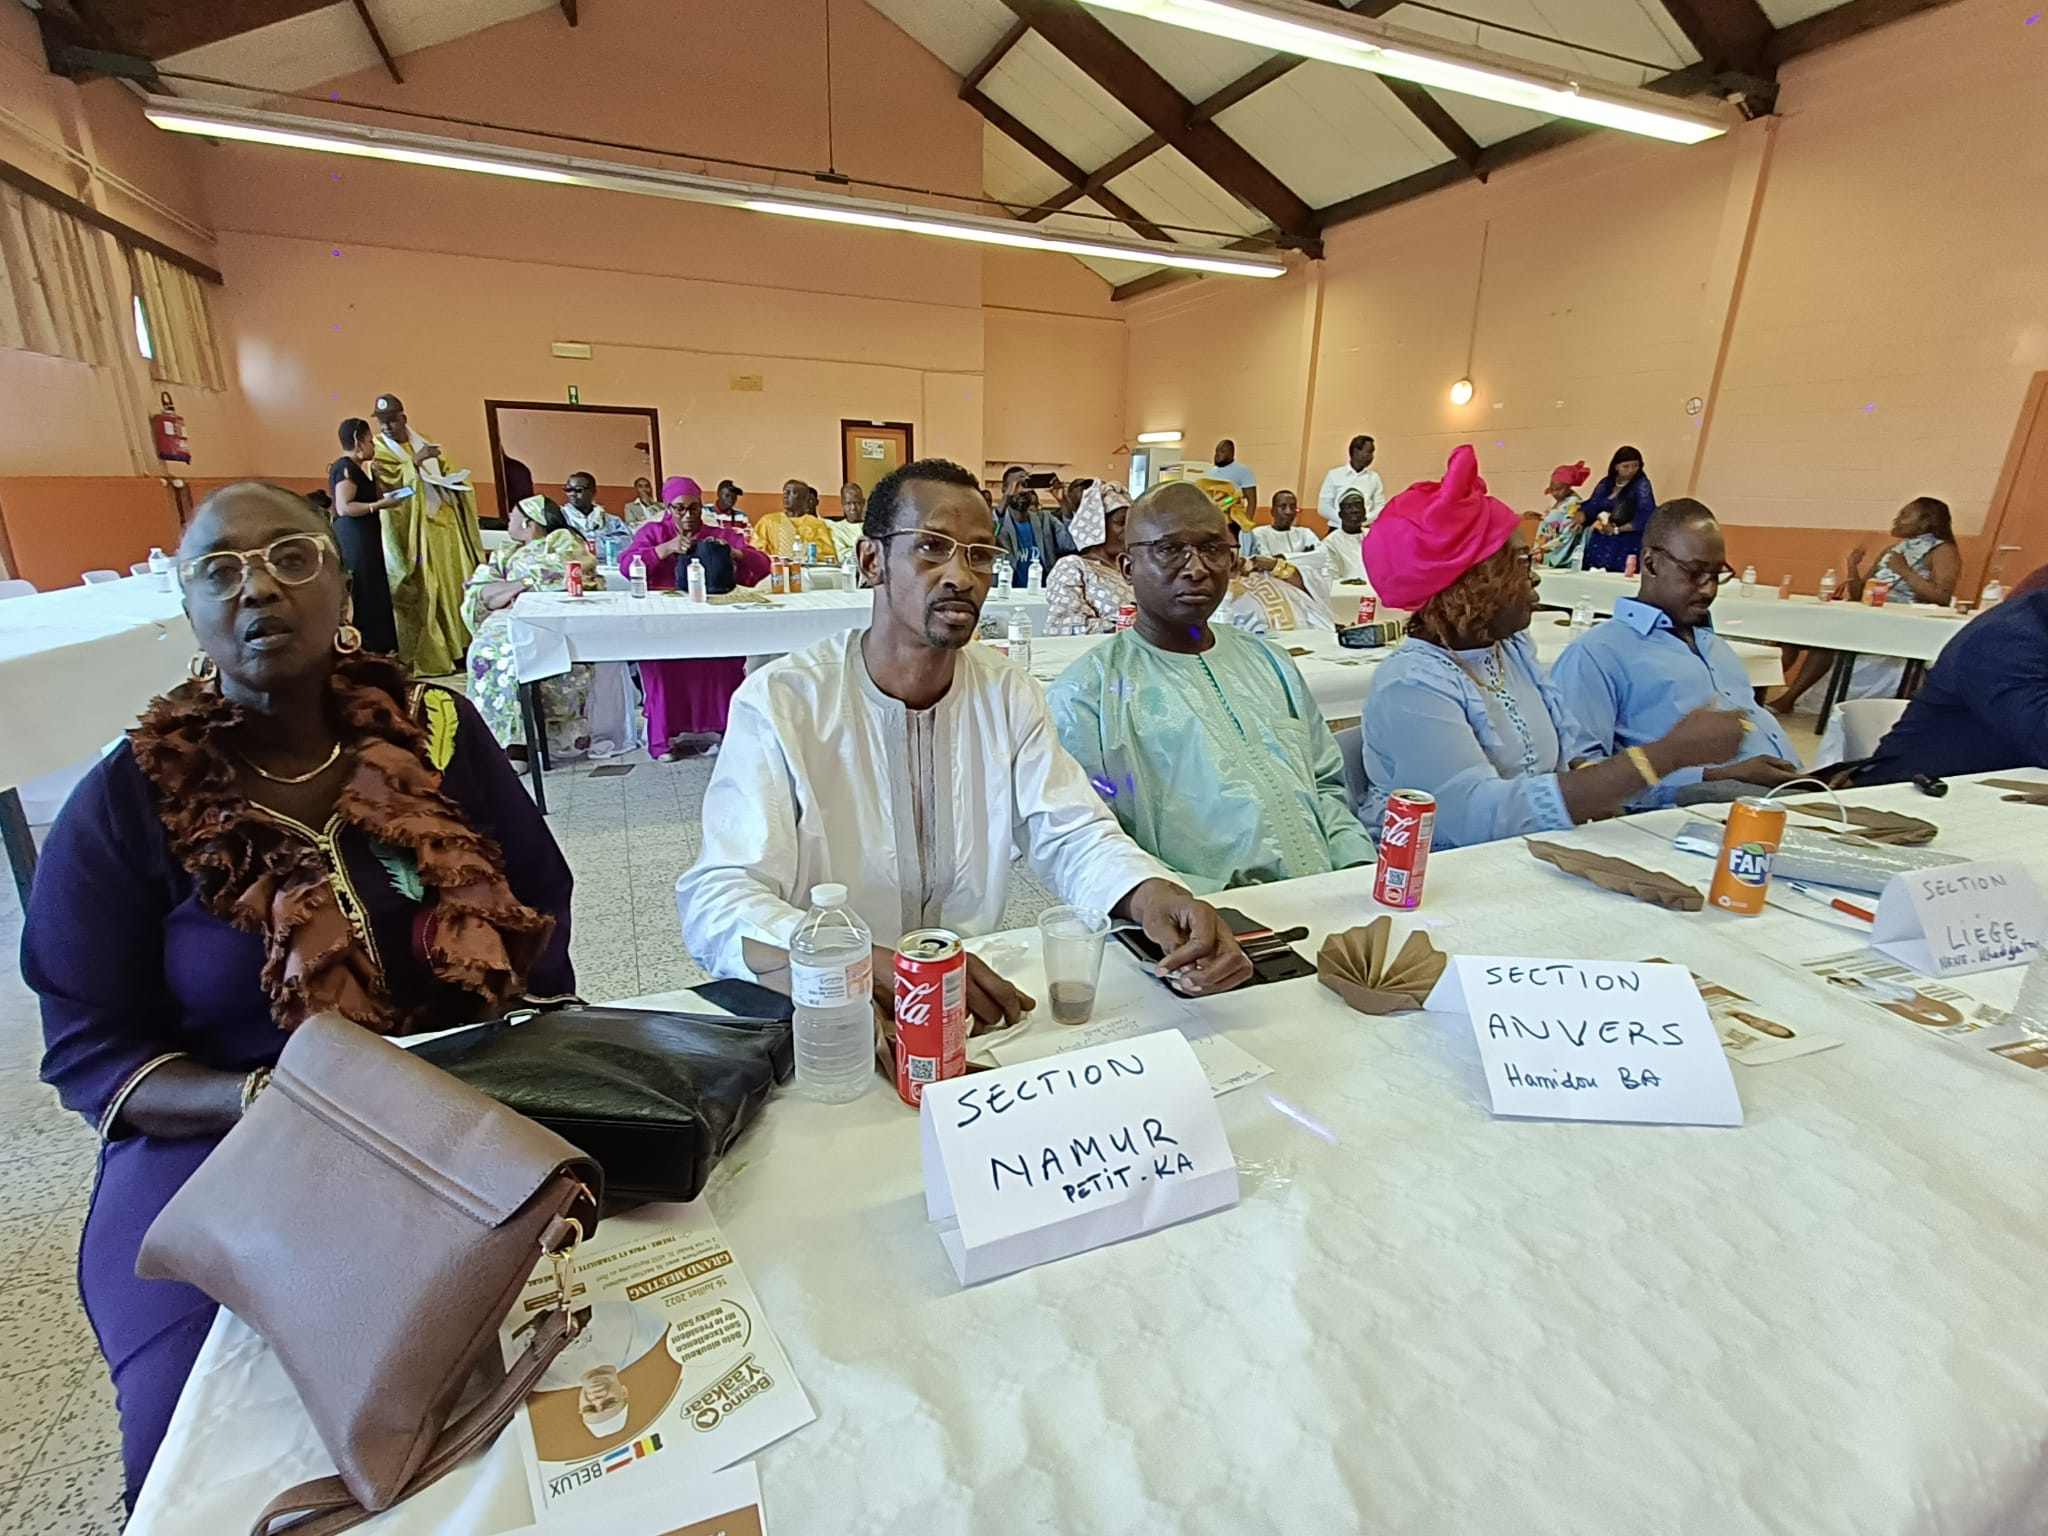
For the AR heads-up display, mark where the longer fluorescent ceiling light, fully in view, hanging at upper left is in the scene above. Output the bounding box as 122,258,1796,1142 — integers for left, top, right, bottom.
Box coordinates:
143,96,1286,276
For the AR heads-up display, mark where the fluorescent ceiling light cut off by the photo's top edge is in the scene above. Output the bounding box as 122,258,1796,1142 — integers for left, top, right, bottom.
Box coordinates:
1083,0,1729,143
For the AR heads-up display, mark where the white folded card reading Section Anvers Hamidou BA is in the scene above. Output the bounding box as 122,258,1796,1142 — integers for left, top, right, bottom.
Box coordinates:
1427,954,1743,1124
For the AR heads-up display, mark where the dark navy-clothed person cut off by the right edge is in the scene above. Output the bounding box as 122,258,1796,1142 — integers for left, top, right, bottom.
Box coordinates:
1855,590,2048,784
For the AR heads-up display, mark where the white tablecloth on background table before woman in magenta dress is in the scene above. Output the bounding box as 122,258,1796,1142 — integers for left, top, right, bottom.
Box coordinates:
512,590,1044,682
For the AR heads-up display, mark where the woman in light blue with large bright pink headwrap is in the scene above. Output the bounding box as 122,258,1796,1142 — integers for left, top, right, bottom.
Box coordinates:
1362,446,1743,848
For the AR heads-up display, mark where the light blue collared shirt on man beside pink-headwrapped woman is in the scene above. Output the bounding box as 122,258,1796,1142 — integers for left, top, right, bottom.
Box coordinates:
1550,598,1800,811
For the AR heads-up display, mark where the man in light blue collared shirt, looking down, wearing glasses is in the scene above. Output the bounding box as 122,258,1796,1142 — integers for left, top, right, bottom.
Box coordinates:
1550,498,1804,811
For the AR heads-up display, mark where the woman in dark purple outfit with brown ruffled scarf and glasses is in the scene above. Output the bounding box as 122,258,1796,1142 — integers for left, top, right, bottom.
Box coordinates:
23,481,575,1501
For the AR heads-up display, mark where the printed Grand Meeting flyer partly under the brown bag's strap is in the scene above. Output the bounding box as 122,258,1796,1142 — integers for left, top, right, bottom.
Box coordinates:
500,1200,817,1522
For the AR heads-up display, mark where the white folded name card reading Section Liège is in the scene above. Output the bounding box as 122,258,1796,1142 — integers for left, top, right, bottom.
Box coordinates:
1870,860,2048,977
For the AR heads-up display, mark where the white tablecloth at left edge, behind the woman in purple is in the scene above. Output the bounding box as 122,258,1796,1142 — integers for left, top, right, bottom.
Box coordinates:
0,575,199,788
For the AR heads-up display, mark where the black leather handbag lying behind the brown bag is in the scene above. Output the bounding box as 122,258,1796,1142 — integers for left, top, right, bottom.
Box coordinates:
414,983,797,1204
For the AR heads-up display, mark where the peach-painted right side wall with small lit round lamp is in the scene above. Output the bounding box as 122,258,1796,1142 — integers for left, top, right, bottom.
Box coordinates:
1126,0,2048,586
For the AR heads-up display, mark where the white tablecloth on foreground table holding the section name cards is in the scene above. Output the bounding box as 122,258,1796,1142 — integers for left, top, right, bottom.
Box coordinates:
129,782,2048,1536
